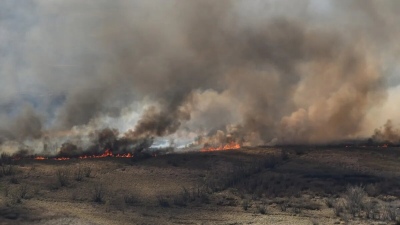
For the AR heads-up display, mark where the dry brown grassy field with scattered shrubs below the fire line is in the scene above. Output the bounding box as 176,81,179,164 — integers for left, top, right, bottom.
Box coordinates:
0,147,400,225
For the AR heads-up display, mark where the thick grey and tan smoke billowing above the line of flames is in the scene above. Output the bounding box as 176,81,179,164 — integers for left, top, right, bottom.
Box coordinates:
0,0,400,155
